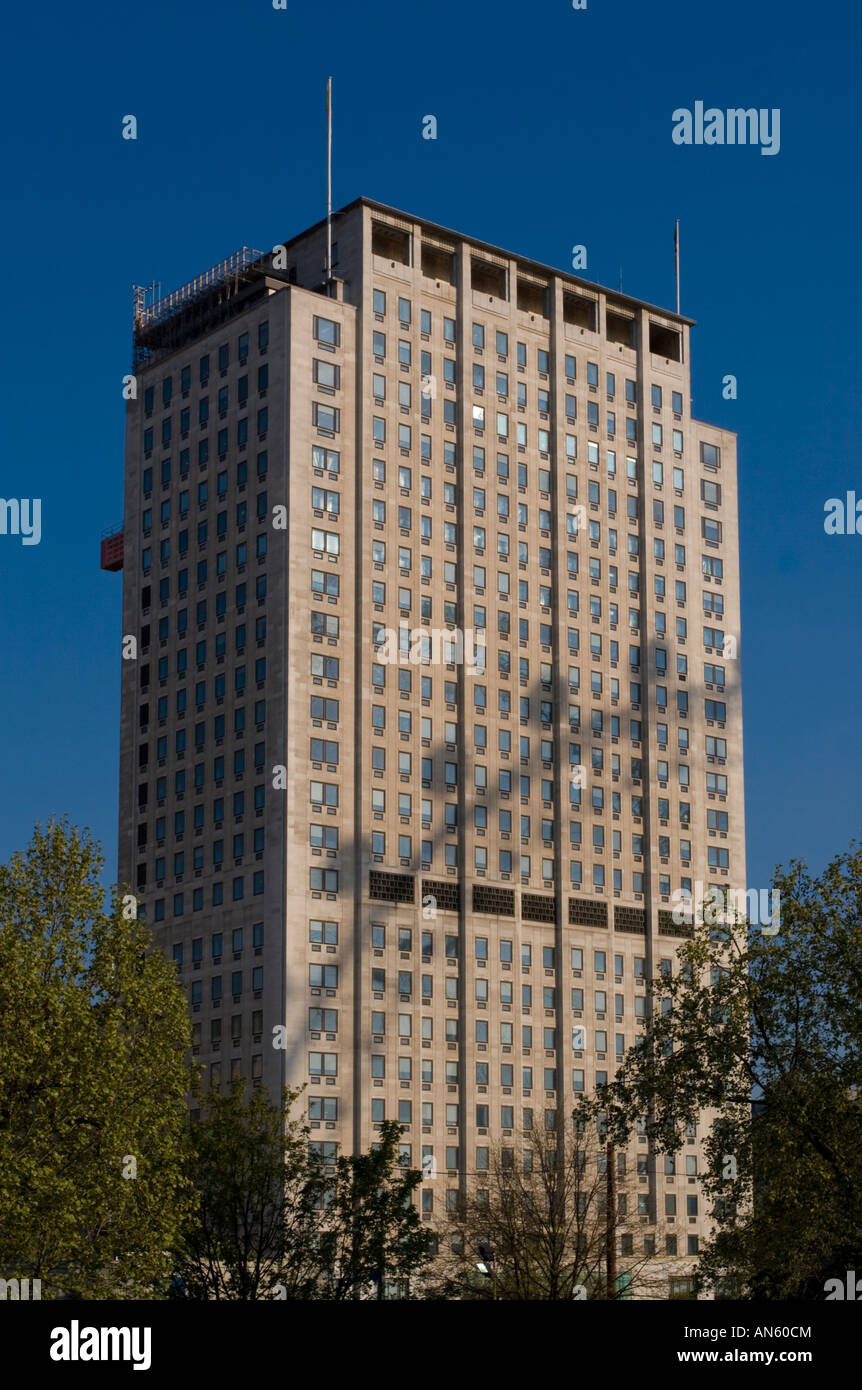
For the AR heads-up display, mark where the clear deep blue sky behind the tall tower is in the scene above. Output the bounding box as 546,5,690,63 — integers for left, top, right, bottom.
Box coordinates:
0,0,862,885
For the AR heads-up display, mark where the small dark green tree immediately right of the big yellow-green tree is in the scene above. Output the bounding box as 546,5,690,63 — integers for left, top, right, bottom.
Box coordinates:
174,1079,323,1300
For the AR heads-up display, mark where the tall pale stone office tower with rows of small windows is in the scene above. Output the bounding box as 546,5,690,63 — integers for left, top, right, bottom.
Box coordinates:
114,199,745,1295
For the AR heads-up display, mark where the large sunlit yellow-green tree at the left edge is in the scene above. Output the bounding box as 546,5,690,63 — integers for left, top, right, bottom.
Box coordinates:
0,821,189,1298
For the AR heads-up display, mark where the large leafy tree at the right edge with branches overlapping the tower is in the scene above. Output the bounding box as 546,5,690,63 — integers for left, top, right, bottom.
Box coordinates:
572,845,862,1300
